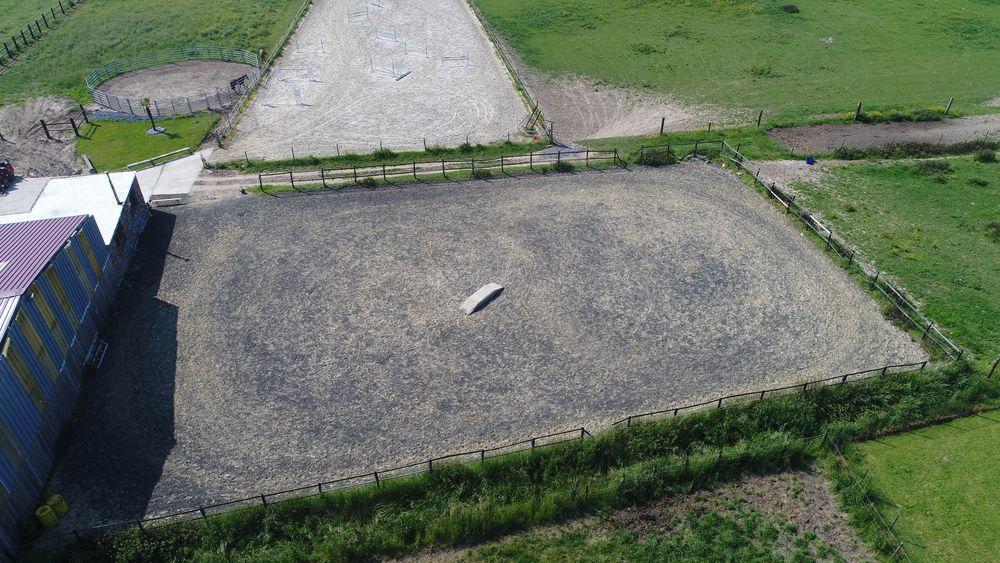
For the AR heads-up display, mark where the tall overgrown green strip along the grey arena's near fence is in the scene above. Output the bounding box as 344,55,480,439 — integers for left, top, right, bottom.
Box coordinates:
35,364,998,560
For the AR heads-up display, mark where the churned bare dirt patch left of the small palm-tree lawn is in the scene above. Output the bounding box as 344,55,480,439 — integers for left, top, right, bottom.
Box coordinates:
0,96,80,177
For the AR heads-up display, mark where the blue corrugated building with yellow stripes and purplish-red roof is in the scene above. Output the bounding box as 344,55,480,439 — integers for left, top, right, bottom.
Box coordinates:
0,175,147,555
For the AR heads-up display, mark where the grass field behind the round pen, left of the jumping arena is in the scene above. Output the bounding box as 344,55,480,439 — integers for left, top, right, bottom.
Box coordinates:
0,0,302,105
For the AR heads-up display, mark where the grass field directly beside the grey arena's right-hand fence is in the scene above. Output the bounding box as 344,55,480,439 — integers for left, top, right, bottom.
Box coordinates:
796,156,1000,367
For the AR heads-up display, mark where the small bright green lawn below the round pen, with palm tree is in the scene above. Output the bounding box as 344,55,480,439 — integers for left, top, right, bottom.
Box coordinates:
76,114,219,171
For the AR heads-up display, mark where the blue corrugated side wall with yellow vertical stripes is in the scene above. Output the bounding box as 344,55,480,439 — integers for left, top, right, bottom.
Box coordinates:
0,212,147,549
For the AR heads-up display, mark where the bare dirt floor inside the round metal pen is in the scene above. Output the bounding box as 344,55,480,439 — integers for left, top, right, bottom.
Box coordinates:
100,61,253,104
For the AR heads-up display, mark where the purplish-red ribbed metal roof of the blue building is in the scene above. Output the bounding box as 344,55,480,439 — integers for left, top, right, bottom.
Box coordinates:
0,215,87,299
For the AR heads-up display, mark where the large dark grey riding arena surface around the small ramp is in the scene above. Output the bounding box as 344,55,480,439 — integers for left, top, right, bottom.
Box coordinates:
51,163,924,526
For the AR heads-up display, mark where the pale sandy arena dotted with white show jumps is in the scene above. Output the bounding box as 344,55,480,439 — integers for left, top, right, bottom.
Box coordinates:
215,0,528,160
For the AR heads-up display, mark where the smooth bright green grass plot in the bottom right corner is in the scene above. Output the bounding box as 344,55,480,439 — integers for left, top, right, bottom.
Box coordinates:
860,413,1000,561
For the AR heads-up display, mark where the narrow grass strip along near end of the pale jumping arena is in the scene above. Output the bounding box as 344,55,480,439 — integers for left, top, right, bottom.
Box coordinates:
212,141,549,173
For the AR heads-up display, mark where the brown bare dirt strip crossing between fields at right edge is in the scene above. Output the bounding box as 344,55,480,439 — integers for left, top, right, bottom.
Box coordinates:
767,114,1000,153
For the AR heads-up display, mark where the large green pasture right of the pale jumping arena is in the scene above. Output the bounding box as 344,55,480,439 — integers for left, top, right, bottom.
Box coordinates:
478,0,1000,118
